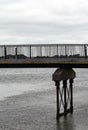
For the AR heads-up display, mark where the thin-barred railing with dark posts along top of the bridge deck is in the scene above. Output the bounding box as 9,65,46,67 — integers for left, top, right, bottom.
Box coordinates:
0,44,88,58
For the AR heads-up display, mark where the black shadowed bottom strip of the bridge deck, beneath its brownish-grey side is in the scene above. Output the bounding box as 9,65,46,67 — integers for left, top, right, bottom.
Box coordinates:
0,63,88,68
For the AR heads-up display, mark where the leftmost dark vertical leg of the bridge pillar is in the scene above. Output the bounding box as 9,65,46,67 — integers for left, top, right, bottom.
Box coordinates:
55,81,60,119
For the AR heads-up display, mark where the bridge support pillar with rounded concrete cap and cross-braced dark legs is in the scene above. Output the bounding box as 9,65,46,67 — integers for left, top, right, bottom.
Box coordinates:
53,69,75,119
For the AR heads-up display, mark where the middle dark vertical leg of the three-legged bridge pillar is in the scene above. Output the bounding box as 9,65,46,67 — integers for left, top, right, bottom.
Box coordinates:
63,80,67,116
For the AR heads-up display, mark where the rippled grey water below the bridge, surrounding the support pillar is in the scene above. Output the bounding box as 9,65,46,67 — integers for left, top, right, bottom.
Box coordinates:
0,68,88,130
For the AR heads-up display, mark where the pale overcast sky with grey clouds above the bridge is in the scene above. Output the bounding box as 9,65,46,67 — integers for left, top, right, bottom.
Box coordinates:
0,0,88,44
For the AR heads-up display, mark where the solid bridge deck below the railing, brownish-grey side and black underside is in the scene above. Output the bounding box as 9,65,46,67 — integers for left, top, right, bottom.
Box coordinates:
0,58,88,68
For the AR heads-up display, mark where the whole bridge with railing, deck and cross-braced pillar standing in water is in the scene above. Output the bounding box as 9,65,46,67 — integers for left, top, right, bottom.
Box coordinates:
0,44,88,119
